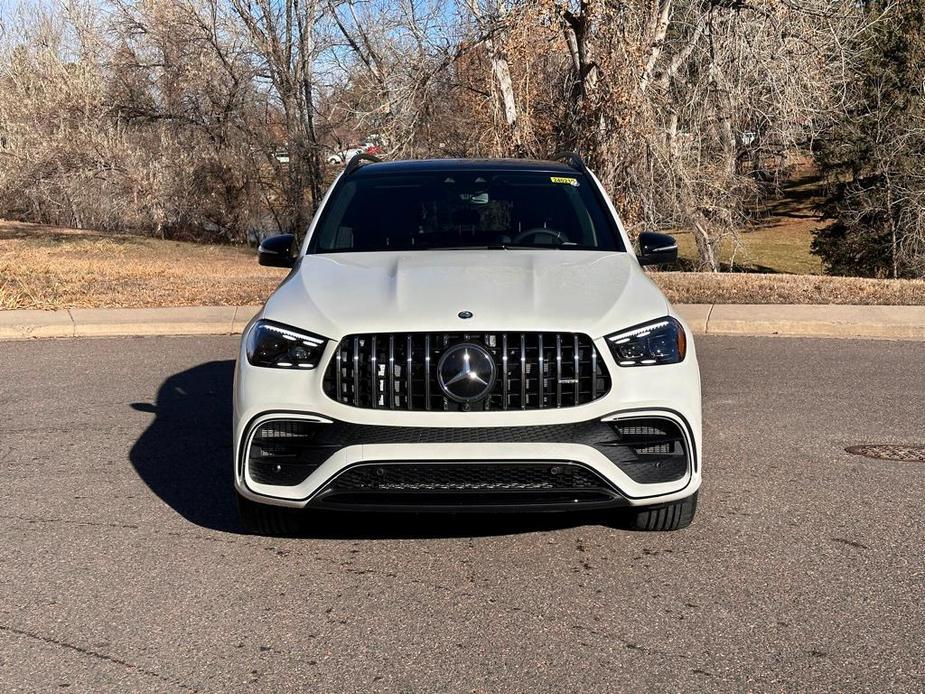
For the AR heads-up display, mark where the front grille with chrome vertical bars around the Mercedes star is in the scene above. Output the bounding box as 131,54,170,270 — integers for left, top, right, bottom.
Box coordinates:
324,332,610,411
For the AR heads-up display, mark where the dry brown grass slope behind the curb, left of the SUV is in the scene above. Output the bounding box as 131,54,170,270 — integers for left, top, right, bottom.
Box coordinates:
0,221,286,309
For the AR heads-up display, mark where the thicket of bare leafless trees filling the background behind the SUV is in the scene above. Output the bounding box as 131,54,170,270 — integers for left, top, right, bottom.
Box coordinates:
0,0,880,270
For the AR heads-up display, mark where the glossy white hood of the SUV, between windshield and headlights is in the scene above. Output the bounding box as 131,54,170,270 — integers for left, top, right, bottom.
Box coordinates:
264,249,668,339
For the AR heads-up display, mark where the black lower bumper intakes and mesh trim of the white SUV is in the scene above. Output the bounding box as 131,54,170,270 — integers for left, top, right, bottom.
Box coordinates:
240,415,692,511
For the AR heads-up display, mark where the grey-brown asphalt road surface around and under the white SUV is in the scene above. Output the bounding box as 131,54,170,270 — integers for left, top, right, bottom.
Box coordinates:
0,337,925,693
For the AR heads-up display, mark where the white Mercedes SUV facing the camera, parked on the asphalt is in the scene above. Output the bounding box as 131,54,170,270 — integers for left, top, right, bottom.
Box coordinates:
234,155,701,534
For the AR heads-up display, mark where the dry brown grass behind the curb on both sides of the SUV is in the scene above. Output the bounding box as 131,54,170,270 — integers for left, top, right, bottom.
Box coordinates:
0,221,925,309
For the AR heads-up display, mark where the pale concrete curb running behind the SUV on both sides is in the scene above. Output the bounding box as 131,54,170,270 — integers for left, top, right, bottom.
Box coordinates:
0,304,925,340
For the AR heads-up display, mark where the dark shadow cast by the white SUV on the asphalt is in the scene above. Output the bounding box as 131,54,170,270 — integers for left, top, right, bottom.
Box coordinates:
129,360,613,539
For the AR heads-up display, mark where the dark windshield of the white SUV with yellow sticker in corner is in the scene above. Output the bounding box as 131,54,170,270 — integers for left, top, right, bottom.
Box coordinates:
309,171,624,253
